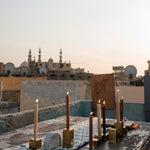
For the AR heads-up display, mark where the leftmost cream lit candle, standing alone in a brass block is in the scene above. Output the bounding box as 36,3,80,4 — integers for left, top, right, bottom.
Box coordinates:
34,99,39,140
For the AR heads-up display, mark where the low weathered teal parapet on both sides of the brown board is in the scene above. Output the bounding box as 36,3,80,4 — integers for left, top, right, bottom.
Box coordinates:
0,100,145,133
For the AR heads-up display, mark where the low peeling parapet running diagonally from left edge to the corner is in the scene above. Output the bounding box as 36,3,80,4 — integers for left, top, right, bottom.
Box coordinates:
0,101,83,133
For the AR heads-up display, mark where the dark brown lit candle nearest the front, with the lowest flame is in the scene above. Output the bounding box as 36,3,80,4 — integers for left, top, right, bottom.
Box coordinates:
89,112,93,148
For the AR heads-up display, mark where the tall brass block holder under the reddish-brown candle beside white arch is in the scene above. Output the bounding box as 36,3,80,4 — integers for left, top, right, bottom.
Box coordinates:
63,129,74,148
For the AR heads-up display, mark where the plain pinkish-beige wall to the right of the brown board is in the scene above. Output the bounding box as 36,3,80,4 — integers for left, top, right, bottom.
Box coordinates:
115,86,144,104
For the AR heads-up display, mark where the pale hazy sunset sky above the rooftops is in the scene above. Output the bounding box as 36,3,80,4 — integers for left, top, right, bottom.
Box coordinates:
0,0,150,75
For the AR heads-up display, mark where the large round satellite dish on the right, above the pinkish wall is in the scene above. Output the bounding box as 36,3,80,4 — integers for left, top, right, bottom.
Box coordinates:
124,65,137,79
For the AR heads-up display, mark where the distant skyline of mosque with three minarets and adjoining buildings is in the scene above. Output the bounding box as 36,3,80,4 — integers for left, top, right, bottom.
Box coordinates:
0,48,91,79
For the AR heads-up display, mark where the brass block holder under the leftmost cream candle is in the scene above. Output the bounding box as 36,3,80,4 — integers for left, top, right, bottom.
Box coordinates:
29,139,42,150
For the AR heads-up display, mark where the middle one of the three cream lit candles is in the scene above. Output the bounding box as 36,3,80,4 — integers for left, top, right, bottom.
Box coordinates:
97,99,101,136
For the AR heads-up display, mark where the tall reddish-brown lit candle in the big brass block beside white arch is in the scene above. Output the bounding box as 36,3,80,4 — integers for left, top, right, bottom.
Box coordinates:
66,91,70,130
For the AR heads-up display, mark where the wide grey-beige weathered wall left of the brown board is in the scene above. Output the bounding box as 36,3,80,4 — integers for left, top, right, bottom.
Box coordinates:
20,80,91,111
